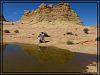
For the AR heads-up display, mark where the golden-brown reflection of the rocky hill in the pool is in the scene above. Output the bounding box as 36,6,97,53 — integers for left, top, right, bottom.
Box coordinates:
21,44,74,64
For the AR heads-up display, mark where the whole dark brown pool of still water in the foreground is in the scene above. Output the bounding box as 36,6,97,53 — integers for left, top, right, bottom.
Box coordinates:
3,44,96,72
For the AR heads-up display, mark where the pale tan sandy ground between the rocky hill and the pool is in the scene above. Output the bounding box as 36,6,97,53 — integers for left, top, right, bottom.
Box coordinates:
3,21,97,54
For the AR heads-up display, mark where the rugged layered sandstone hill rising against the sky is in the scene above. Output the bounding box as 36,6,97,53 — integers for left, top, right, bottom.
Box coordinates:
21,3,82,25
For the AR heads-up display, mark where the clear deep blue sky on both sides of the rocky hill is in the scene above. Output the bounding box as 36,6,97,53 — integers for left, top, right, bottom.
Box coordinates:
3,3,97,25
